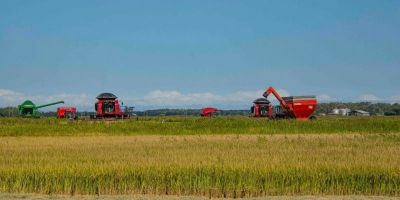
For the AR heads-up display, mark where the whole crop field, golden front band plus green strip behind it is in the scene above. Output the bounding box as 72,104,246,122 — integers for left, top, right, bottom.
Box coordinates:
0,117,400,198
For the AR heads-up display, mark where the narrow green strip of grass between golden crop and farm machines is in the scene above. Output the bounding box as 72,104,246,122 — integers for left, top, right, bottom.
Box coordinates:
0,117,400,136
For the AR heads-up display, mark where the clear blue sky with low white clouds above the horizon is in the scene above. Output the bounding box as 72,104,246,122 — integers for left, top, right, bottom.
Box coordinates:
0,0,400,109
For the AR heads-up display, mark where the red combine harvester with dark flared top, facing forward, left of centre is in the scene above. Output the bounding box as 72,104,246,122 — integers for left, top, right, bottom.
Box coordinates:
91,93,129,119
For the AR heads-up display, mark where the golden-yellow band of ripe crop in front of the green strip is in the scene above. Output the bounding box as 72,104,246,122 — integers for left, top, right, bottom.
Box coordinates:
0,133,400,197
